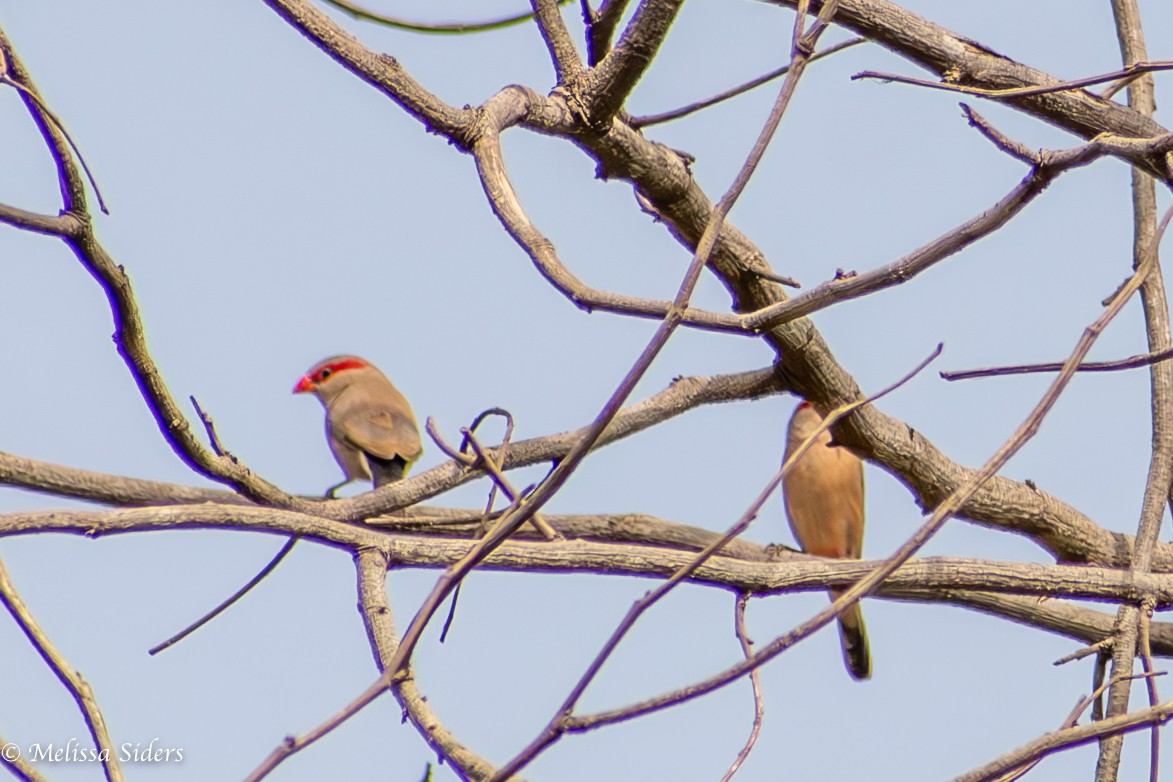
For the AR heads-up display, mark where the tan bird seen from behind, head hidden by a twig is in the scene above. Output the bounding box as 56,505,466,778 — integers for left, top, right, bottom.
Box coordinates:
782,401,872,679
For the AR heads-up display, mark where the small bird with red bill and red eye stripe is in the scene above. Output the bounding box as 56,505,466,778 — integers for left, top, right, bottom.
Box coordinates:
293,355,423,497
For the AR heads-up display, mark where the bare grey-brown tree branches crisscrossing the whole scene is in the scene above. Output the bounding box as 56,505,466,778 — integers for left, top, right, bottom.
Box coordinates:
0,0,1173,782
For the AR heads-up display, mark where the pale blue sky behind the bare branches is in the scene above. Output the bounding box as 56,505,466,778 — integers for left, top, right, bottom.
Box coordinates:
0,0,1173,781
